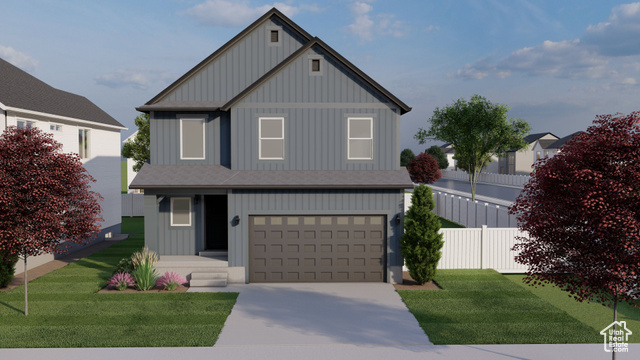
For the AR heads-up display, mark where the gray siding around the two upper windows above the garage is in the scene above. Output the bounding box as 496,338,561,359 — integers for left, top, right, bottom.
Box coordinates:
231,104,400,170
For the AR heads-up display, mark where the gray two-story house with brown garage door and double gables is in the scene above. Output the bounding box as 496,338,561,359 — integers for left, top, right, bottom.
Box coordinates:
131,9,412,282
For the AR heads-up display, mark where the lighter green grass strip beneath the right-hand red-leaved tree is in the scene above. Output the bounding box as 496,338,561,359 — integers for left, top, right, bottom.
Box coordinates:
505,274,640,343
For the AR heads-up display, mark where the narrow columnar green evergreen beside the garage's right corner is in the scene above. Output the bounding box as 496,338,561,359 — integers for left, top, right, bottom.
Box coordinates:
400,184,444,284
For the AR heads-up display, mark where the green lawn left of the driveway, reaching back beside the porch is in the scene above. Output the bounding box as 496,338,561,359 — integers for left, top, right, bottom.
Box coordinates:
0,218,238,348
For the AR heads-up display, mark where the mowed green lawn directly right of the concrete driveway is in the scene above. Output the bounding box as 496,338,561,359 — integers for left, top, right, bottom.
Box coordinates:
398,270,602,344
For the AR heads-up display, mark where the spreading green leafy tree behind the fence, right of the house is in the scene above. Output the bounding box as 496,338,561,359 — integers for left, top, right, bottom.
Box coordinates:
414,95,530,200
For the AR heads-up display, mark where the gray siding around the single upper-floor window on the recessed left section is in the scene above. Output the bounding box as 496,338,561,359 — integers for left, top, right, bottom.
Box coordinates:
150,112,231,166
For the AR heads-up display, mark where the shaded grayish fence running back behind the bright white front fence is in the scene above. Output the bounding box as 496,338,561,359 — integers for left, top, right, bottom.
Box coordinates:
404,191,518,228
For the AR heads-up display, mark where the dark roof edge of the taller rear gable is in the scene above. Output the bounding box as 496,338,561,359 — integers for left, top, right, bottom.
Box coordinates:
142,8,313,106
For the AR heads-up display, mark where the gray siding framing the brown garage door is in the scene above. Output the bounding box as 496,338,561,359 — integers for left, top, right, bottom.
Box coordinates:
228,190,404,266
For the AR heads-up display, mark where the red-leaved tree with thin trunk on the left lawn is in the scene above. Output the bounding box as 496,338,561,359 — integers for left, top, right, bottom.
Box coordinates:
0,126,102,315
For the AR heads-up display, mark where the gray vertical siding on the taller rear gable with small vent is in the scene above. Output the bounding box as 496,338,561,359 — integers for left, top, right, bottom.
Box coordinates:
162,18,304,101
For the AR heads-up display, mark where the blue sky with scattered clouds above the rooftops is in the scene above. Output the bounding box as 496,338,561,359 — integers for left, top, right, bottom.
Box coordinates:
0,0,640,153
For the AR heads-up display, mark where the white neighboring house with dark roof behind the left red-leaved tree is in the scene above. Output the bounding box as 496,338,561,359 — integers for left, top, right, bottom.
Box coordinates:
0,59,126,267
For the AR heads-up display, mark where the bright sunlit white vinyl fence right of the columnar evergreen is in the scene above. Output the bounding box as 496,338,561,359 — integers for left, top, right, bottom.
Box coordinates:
438,226,527,273
